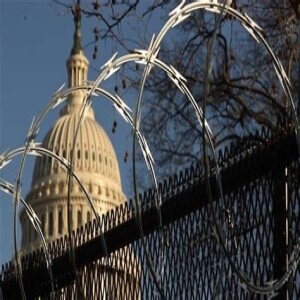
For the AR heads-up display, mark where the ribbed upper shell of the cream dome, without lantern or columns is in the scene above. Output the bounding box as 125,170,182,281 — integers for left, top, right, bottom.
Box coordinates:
32,113,121,187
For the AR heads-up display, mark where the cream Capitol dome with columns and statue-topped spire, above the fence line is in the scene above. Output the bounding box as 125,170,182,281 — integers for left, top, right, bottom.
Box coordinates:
20,8,126,253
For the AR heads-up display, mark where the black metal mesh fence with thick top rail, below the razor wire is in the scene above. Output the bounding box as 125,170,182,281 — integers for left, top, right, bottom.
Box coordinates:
0,127,300,299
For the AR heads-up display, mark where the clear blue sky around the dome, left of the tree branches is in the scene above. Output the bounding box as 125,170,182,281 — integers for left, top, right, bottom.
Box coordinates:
0,0,159,266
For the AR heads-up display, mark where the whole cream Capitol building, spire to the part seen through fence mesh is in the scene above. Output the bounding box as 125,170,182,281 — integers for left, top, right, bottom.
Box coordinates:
20,10,140,299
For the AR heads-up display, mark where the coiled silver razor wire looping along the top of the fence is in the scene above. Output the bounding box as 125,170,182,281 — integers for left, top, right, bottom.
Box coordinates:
0,0,300,299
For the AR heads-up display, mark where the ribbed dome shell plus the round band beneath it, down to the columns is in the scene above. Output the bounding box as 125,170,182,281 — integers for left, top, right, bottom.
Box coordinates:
26,106,126,213
